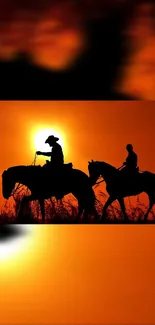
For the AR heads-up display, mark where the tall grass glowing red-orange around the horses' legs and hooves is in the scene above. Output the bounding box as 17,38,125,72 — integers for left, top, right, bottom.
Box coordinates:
0,192,155,224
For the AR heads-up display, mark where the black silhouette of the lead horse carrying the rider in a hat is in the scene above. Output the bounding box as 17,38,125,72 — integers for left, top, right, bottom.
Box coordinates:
2,164,97,221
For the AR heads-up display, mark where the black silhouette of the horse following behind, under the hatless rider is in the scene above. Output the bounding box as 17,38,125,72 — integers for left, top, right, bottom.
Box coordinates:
88,160,155,221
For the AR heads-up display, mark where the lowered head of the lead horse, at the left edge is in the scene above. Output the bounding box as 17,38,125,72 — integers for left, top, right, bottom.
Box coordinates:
2,169,15,199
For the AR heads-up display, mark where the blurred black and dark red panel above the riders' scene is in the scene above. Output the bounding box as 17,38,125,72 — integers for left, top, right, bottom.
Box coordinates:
0,0,155,100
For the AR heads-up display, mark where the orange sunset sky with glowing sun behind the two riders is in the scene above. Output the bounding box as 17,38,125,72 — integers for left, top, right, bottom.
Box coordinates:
0,101,155,204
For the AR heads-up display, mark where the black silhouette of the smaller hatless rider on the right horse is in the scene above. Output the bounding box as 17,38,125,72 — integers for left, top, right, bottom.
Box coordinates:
121,144,138,175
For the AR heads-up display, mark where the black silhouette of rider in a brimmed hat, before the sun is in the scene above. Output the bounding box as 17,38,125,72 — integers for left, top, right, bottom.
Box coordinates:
36,135,64,168
